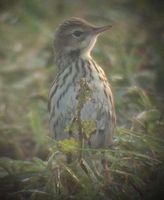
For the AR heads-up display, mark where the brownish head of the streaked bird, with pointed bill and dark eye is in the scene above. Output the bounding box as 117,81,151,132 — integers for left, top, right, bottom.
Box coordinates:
54,18,111,56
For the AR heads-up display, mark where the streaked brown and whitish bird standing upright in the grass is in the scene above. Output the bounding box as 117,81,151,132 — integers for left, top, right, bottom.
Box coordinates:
48,17,116,152
